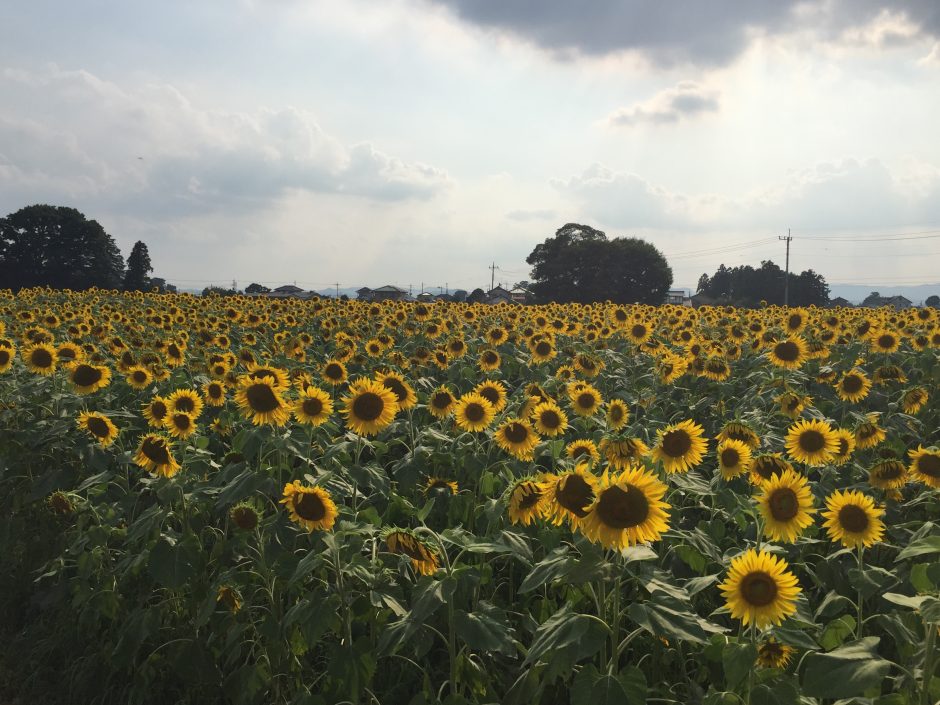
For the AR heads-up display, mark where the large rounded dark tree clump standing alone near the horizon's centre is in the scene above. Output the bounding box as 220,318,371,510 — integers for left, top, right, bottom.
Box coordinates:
526,223,672,304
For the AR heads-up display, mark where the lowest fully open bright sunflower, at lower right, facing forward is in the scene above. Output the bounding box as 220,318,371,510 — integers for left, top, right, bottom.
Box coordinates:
718,548,800,629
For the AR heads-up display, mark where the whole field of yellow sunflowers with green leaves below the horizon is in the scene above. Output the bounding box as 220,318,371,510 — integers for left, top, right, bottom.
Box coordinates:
0,289,940,705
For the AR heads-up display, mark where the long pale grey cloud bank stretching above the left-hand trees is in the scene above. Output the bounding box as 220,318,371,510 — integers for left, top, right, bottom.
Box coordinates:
0,67,450,217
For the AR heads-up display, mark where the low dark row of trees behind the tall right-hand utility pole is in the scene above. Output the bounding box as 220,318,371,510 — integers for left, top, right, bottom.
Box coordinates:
698,260,829,308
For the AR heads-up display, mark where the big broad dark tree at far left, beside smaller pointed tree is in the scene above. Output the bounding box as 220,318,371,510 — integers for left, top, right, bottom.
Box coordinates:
0,205,124,289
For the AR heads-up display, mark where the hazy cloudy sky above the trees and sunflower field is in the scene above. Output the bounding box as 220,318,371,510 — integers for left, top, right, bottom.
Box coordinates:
0,0,940,292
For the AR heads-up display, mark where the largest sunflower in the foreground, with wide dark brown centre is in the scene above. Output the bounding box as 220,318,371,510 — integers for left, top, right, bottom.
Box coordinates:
579,467,670,550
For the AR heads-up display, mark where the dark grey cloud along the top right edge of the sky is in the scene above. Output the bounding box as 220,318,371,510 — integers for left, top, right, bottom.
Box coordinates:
428,0,940,66
